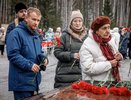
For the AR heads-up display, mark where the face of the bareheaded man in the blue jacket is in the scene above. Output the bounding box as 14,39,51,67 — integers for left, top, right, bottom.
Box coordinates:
25,12,41,30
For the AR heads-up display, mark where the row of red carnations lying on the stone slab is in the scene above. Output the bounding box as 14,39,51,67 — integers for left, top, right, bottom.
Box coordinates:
71,80,131,96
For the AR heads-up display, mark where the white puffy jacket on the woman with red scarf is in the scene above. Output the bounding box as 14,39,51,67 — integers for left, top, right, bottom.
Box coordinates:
80,32,118,81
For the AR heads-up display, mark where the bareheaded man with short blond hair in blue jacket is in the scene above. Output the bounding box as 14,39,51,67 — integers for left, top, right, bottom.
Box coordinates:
7,7,48,100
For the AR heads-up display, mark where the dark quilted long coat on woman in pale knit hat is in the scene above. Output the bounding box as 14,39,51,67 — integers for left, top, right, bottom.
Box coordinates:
54,31,87,88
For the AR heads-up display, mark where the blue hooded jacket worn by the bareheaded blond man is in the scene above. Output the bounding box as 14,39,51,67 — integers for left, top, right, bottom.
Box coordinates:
7,21,42,91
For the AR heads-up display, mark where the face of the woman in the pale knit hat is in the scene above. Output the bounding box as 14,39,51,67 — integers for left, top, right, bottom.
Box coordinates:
71,17,83,29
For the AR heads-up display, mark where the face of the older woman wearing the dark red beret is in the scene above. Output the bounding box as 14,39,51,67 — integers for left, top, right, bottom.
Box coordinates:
96,24,110,39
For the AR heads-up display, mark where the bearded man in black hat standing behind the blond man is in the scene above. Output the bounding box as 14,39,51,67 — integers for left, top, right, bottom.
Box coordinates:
5,2,27,40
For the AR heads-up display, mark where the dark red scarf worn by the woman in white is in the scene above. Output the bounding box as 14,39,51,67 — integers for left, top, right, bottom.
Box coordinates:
93,33,120,81
